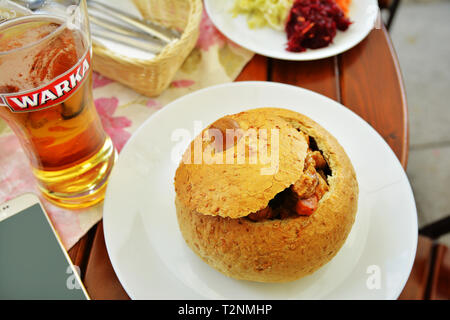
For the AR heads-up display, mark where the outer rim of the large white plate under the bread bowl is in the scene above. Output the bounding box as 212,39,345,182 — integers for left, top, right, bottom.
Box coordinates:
102,81,418,300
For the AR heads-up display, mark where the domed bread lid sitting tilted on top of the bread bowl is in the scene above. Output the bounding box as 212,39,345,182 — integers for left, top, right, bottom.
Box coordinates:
175,109,308,218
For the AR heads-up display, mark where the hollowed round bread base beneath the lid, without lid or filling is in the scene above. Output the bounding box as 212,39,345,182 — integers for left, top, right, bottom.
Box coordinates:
175,108,358,282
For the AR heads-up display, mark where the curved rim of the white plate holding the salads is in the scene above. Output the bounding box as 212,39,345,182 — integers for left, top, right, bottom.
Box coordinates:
204,0,380,61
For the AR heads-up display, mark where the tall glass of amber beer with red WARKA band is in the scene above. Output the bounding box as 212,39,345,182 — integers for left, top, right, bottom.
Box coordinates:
0,0,117,208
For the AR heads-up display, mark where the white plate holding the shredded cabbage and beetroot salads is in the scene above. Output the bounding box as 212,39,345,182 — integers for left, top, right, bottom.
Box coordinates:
205,0,379,60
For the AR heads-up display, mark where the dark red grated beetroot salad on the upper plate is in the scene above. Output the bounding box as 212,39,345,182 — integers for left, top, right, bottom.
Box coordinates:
286,0,351,52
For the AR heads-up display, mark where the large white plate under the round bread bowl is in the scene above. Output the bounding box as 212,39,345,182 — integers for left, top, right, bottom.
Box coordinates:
103,82,417,299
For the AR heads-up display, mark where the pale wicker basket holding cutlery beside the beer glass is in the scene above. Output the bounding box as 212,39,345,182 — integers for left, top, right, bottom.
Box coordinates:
93,0,203,97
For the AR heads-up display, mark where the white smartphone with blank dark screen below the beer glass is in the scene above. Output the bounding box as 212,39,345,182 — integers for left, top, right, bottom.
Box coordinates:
0,193,89,300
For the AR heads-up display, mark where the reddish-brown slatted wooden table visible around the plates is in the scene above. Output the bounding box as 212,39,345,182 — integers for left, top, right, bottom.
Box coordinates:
69,28,408,299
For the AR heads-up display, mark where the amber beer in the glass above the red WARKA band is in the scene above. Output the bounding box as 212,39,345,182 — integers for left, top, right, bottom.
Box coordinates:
0,20,86,91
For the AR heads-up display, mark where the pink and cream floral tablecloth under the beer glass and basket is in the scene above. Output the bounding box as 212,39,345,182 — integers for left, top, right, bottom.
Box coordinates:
0,12,253,249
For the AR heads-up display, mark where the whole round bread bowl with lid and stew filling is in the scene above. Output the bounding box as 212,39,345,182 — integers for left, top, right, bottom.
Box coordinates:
175,108,358,282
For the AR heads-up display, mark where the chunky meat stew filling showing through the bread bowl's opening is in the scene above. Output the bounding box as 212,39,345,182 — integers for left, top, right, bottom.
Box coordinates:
247,135,331,221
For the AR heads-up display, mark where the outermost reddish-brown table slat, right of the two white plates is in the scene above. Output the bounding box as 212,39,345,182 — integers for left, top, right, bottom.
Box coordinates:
339,27,408,168
